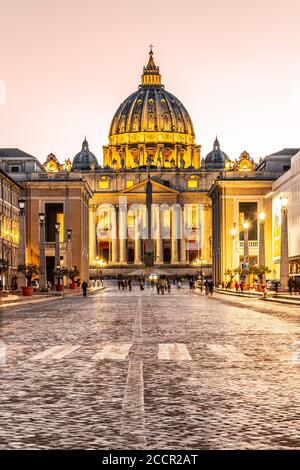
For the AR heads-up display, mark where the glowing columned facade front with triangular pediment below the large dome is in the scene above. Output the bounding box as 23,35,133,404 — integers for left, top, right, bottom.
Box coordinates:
89,174,210,267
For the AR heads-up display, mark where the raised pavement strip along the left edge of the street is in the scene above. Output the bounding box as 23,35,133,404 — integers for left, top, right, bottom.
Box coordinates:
0,287,105,310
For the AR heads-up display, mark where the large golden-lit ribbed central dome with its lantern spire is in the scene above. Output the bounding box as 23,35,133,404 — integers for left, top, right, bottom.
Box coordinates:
104,49,200,168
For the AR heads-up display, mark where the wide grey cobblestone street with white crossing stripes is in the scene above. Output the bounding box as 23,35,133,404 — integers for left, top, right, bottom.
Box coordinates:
0,285,300,450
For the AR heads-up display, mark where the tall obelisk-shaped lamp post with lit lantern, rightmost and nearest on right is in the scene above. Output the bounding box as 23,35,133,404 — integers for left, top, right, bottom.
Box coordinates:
279,197,289,291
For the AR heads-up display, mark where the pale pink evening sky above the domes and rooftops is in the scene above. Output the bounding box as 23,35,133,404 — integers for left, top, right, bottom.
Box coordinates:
0,0,300,162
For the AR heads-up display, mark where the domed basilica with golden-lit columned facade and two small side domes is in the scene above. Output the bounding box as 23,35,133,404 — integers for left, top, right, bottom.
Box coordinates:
72,50,230,272
